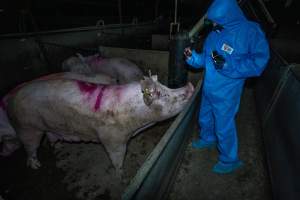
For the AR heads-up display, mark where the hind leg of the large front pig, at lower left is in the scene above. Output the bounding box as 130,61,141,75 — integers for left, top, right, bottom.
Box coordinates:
18,129,43,169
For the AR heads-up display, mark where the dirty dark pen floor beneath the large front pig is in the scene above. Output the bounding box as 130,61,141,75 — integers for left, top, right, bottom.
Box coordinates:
0,119,173,200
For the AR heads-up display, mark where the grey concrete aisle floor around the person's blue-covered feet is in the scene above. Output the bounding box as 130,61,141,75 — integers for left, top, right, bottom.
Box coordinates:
169,88,271,200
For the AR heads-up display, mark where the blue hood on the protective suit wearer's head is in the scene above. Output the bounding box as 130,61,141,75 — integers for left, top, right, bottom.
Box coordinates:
206,0,246,28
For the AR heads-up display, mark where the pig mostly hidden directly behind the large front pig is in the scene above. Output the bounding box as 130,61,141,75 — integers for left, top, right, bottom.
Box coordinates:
0,72,117,156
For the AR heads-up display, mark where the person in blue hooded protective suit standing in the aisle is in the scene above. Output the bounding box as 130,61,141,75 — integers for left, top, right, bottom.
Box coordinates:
184,0,269,173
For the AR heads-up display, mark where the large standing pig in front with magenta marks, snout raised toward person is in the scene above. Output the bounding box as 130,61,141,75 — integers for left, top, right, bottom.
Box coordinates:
7,76,194,172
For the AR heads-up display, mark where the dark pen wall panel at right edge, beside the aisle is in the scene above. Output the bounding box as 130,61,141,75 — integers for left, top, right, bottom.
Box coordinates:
262,65,300,200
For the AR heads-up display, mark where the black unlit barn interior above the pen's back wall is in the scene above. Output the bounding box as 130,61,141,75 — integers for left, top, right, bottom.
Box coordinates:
0,0,300,33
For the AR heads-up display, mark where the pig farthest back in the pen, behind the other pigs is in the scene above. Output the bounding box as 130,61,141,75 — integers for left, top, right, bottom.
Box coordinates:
62,54,143,84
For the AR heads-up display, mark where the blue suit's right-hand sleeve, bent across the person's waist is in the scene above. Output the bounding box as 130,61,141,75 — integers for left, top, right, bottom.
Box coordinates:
219,27,270,78
